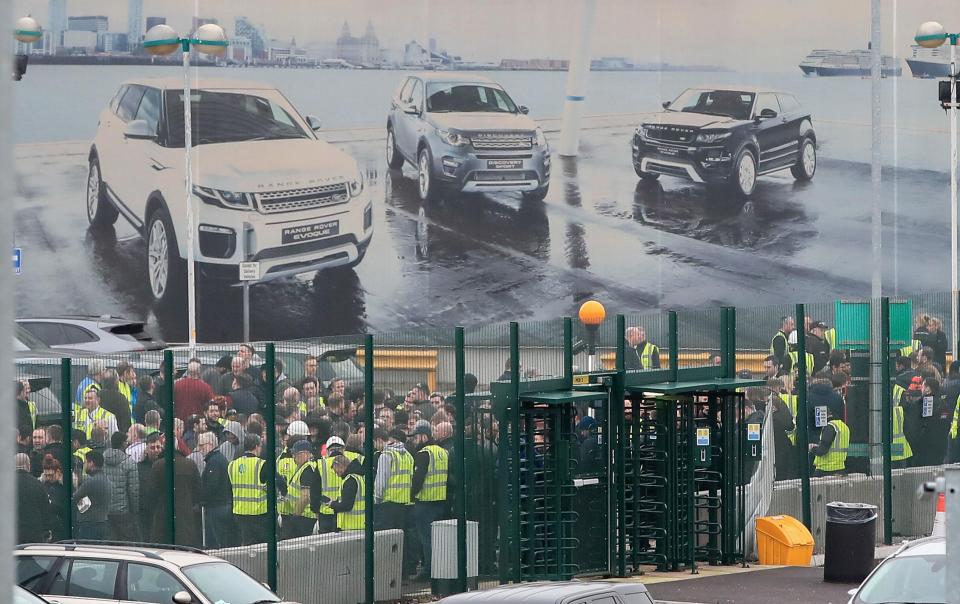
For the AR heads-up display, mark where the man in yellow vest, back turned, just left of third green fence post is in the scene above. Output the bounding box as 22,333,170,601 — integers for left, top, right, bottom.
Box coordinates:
227,434,270,545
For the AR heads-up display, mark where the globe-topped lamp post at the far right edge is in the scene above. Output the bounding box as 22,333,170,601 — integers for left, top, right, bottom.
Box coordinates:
913,21,960,358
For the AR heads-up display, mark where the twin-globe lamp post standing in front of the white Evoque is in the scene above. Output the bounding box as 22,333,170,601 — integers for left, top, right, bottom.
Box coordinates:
143,23,229,354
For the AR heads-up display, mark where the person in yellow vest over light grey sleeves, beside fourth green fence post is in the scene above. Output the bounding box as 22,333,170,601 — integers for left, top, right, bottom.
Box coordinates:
373,429,413,532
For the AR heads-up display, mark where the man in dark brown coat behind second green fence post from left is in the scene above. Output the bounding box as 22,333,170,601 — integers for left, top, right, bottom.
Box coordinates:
147,438,202,547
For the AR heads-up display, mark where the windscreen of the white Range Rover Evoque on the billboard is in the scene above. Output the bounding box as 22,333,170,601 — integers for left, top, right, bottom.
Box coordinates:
165,90,309,147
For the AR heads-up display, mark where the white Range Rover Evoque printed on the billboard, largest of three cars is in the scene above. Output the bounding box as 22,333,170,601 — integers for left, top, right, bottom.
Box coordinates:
87,78,373,302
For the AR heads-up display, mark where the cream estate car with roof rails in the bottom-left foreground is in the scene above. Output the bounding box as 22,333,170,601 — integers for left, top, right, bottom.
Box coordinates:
14,541,298,604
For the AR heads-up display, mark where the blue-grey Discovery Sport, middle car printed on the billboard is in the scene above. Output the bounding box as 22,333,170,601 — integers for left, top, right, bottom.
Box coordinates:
386,73,550,200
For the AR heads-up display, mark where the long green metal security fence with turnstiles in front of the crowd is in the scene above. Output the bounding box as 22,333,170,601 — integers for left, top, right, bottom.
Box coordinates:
16,294,960,604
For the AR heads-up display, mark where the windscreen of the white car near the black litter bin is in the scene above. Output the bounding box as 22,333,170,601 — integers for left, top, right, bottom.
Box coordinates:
855,555,947,604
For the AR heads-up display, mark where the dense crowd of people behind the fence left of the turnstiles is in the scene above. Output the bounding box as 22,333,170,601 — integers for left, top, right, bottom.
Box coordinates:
16,344,458,578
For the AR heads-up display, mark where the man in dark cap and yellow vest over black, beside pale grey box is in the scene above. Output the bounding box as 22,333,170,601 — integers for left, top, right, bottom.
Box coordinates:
410,422,450,580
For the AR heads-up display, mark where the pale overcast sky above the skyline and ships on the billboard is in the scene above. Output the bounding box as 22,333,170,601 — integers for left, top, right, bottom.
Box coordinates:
14,0,960,71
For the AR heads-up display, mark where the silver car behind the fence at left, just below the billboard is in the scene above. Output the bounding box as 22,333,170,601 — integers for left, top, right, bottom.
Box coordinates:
17,315,166,353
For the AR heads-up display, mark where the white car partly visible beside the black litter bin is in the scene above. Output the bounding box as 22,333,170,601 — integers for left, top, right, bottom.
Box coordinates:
849,537,944,604
